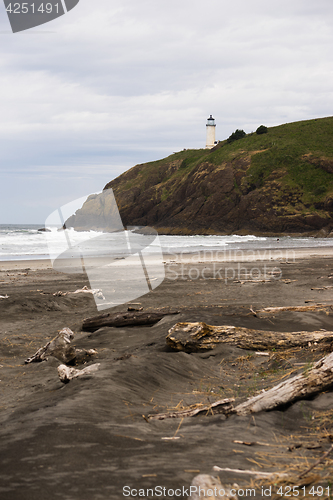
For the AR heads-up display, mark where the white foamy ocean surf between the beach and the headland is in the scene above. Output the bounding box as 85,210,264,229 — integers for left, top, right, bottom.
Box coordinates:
0,224,333,261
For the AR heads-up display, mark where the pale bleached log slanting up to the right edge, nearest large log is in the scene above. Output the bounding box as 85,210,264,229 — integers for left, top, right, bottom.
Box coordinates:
234,353,333,415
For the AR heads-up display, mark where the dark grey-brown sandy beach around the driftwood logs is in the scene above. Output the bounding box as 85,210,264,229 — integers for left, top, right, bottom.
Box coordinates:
0,254,333,500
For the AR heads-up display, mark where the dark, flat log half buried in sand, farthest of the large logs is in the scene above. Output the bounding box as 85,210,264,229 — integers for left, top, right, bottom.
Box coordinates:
82,311,179,332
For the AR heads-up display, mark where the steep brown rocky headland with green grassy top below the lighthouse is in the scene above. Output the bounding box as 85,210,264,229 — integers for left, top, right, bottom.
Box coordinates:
72,117,333,235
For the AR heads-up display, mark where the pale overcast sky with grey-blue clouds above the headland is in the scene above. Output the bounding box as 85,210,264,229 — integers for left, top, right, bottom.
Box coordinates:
0,0,333,224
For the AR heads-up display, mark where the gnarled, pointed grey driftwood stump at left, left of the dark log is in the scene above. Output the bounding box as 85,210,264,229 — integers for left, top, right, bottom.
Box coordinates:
25,328,97,364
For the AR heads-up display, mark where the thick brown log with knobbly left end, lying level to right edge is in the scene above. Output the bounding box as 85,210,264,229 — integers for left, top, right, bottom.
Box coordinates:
166,322,333,352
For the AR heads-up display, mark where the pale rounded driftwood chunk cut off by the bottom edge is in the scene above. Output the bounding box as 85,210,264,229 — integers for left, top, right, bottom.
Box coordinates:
189,474,238,500
